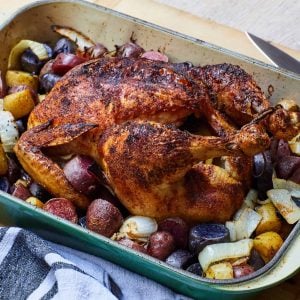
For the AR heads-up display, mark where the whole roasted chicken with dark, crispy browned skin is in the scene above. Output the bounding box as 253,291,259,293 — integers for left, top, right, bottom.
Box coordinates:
15,57,300,222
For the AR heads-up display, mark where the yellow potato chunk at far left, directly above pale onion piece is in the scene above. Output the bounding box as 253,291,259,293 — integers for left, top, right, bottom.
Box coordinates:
3,90,34,120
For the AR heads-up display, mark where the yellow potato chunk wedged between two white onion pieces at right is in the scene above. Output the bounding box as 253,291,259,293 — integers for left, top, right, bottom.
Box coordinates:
255,203,281,235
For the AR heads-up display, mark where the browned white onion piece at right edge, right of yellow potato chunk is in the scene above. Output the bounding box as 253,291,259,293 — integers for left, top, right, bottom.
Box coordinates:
268,189,300,224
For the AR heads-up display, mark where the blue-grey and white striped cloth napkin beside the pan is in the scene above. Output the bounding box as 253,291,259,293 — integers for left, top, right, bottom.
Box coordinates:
0,227,189,300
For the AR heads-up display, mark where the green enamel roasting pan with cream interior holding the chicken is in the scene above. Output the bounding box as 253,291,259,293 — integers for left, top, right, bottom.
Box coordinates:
0,1,300,299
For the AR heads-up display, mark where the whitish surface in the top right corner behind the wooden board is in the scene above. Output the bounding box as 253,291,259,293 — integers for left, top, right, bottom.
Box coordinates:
155,0,300,50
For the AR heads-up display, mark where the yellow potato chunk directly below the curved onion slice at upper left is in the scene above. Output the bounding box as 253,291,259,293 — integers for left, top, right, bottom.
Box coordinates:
5,70,39,91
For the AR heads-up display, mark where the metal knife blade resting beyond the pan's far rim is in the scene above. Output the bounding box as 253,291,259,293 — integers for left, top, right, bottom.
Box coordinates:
246,32,300,74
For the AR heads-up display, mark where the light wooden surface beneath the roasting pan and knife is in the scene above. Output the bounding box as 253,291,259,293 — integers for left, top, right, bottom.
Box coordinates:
0,0,300,300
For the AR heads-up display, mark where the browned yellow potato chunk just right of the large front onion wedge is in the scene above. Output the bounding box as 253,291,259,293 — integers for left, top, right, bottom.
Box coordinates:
253,231,283,263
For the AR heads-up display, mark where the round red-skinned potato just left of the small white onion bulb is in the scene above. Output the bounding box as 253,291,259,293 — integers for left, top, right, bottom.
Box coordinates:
86,199,123,237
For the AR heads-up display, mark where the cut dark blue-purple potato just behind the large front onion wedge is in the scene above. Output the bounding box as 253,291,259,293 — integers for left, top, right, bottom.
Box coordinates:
189,223,230,254
